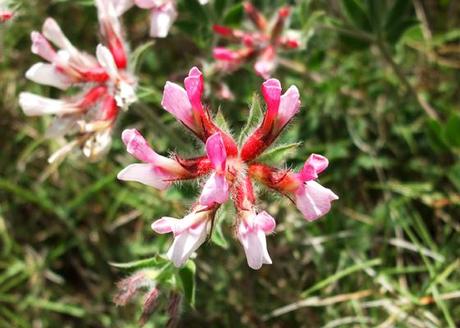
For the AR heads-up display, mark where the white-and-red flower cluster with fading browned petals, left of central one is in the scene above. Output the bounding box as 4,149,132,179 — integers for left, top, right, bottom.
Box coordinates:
19,0,136,162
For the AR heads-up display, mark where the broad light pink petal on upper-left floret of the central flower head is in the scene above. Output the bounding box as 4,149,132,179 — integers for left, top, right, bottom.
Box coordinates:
161,81,195,130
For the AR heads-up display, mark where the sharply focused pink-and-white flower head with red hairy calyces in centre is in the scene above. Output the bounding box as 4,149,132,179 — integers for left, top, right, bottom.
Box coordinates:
118,67,338,269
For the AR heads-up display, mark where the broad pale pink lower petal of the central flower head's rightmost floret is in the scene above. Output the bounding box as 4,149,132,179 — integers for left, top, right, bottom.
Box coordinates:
296,181,339,221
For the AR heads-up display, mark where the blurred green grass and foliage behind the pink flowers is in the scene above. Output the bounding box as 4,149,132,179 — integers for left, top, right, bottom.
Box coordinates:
0,0,460,328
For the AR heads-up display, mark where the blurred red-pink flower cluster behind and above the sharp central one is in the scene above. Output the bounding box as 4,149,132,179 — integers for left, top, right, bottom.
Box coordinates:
213,2,299,79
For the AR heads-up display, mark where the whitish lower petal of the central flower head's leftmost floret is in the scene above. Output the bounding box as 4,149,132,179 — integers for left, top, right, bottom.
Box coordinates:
117,163,171,190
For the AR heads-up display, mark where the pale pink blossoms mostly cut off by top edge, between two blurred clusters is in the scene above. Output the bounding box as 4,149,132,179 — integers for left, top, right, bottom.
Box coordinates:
114,0,208,38
